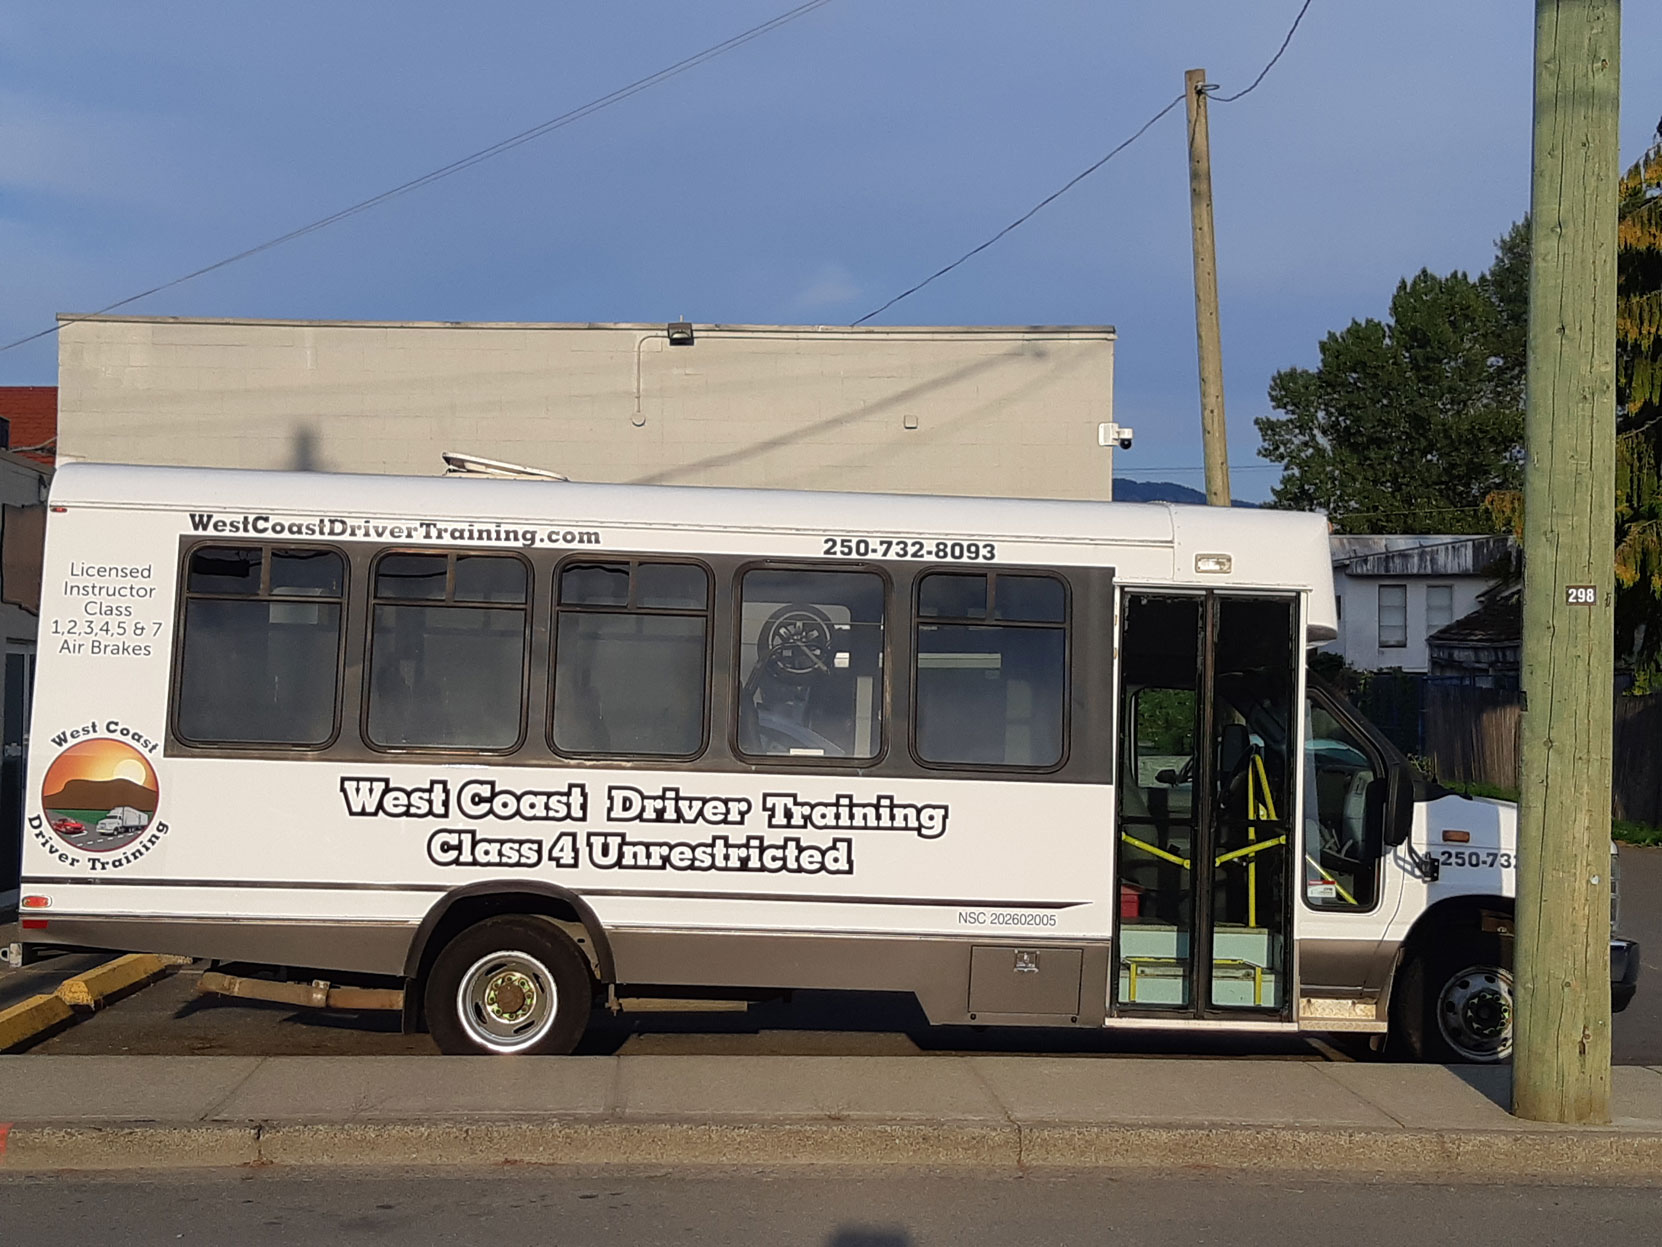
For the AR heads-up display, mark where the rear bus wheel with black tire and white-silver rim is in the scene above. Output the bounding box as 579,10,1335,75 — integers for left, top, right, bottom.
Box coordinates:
422,914,595,1056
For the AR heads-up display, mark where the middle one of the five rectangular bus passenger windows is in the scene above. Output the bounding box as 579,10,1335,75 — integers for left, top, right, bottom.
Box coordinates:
550,560,710,758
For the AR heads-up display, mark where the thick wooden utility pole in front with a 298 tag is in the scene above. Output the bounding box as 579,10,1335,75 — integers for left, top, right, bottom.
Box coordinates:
1512,0,1620,1124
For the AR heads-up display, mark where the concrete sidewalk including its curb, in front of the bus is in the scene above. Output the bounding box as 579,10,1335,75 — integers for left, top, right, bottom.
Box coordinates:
0,1056,1662,1182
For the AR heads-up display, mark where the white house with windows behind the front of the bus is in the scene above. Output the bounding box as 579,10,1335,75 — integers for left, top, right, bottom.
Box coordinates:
1323,534,1519,672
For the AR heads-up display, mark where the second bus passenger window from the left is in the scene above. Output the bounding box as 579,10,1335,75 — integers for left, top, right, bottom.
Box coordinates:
366,552,529,752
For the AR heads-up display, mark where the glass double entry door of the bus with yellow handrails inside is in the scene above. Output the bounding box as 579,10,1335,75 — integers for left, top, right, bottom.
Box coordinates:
1114,592,1301,1018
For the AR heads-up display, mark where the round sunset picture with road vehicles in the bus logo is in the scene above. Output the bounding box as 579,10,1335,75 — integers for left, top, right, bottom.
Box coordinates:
40,737,156,853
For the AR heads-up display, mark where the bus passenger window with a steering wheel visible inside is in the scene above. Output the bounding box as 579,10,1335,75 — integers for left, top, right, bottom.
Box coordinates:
738,569,884,758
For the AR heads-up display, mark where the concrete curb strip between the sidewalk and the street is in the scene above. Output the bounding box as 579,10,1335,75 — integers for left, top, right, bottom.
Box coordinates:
0,1119,1662,1185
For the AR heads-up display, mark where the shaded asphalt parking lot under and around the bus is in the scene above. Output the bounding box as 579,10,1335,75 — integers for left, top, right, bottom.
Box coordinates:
0,846,1662,1064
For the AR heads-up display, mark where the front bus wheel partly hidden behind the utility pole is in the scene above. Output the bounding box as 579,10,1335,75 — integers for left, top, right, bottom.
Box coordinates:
1389,929,1512,1066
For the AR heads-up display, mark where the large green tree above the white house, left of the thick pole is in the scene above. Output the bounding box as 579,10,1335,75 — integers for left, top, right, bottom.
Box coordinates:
1256,224,1529,532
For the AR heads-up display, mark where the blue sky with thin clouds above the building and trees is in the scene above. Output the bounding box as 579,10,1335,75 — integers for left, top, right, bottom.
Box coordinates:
0,0,1662,499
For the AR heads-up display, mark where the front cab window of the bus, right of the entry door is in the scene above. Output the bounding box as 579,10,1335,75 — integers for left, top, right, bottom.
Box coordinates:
1303,700,1379,913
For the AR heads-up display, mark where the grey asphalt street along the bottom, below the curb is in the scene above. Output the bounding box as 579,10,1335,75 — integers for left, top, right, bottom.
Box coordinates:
0,1169,1657,1247
